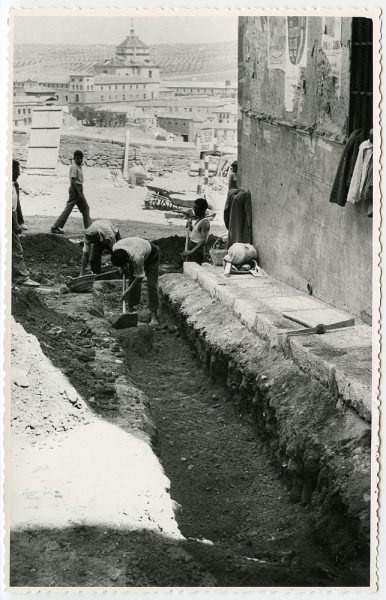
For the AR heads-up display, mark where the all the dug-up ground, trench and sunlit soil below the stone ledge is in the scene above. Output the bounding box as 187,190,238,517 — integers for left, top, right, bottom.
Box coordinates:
10,234,370,587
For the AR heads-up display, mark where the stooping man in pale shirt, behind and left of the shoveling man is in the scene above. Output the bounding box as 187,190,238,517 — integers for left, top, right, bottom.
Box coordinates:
80,219,121,275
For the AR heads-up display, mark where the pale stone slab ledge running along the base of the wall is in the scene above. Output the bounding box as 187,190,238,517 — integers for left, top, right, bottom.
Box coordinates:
184,262,372,422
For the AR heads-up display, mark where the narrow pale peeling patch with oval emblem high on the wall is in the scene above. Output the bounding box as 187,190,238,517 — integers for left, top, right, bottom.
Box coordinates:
284,17,308,112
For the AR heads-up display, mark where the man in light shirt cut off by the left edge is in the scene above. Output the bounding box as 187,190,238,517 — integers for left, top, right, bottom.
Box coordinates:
12,160,39,287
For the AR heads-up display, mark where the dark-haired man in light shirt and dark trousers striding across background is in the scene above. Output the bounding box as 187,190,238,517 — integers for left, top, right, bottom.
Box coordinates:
51,150,91,233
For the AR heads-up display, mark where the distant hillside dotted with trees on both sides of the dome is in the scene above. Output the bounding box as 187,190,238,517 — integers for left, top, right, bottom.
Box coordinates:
14,41,237,81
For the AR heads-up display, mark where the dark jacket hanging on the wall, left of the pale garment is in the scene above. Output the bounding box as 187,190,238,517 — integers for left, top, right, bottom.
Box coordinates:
330,129,365,206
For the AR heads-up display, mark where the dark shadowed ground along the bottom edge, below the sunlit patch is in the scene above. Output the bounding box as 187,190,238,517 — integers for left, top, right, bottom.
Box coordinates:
10,525,322,587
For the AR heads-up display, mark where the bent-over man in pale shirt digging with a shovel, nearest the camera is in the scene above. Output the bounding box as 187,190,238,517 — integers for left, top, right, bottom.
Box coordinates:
111,237,160,326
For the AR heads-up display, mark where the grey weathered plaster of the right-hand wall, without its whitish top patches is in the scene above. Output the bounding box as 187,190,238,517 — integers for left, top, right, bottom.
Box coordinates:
239,17,372,317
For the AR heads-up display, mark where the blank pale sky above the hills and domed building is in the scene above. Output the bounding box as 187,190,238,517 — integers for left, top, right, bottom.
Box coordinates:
14,16,237,45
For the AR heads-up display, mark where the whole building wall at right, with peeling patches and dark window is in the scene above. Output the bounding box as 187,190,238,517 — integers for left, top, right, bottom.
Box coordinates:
238,17,373,319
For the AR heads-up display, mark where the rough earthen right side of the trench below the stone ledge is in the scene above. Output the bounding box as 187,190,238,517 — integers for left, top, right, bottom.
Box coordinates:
160,274,370,561
